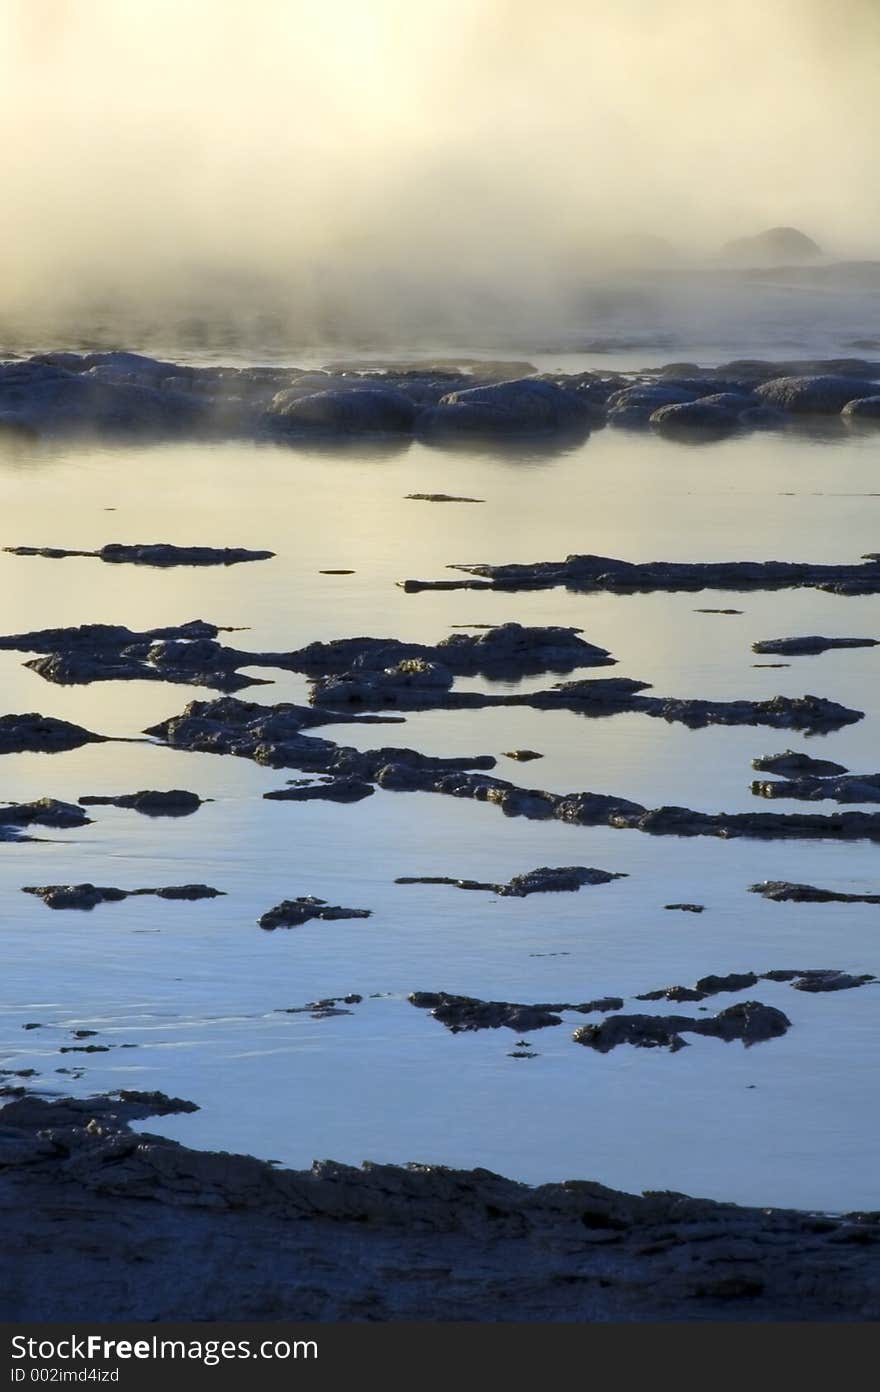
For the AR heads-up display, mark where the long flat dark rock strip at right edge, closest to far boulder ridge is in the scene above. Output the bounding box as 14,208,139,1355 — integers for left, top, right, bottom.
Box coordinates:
401,555,880,594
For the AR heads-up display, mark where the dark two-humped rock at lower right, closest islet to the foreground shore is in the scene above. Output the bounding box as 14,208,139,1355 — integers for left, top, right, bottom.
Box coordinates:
572,1001,791,1054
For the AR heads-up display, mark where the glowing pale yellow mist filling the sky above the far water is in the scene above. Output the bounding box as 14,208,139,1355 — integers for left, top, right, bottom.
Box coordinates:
0,0,880,342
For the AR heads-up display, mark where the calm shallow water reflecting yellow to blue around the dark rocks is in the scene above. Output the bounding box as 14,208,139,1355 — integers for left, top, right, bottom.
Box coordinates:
0,412,880,1208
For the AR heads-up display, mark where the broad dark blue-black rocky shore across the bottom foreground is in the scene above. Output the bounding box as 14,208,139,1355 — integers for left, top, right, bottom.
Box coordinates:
0,1093,880,1321
